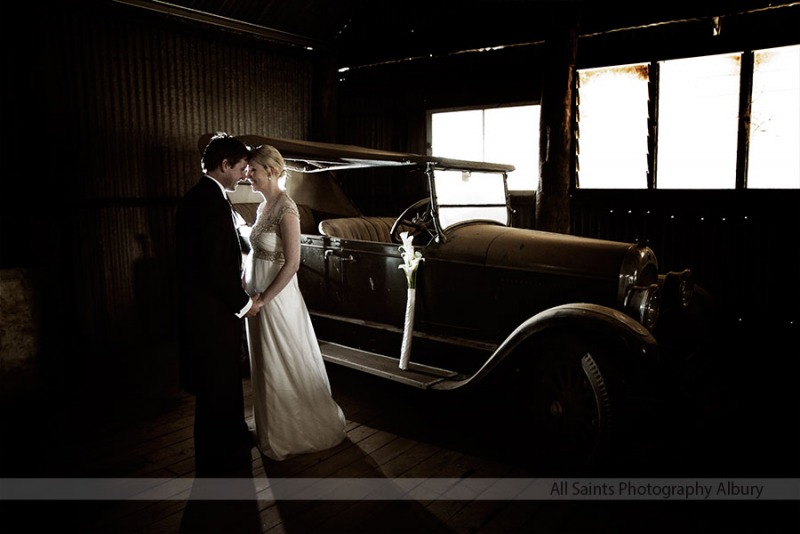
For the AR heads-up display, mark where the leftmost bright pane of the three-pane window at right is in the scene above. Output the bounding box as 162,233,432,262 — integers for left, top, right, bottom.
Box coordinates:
578,64,649,189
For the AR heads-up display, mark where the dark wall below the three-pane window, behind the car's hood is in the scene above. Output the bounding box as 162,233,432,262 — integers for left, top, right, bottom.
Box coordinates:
572,190,800,328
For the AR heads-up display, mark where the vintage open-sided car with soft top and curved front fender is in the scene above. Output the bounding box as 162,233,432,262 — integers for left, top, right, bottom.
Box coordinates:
214,135,708,468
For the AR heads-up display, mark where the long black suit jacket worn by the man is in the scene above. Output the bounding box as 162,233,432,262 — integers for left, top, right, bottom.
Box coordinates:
176,176,249,400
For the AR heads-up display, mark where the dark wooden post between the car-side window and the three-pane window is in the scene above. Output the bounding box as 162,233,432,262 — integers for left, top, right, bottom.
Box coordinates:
536,6,578,233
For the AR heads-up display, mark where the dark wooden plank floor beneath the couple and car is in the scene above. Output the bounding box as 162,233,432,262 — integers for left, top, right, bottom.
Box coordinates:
0,332,800,533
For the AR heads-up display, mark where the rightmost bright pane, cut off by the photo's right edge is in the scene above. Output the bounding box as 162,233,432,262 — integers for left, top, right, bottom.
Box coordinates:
747,45,800,189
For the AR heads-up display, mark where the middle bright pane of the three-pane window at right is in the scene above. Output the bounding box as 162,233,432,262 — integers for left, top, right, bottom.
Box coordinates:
656,54,741,189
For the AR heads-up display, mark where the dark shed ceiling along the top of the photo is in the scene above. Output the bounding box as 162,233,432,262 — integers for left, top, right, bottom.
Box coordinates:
114,0,798,67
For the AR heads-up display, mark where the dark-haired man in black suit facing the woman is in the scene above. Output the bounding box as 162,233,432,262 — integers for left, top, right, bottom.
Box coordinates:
176,133,261,476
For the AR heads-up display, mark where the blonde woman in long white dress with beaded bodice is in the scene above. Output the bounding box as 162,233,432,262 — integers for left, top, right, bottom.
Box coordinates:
244,145,346,460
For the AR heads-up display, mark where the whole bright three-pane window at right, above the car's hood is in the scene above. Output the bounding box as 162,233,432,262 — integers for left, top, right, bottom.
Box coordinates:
576,45,800,189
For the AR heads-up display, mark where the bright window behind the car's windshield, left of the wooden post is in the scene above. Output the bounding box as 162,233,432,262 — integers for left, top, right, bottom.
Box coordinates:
430,105,539,191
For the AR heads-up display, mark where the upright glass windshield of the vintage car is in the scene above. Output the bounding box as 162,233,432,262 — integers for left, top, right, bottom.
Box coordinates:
434,170,509,230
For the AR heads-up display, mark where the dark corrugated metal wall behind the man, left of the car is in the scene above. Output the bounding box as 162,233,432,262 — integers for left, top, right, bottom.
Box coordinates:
32,4,314,376
